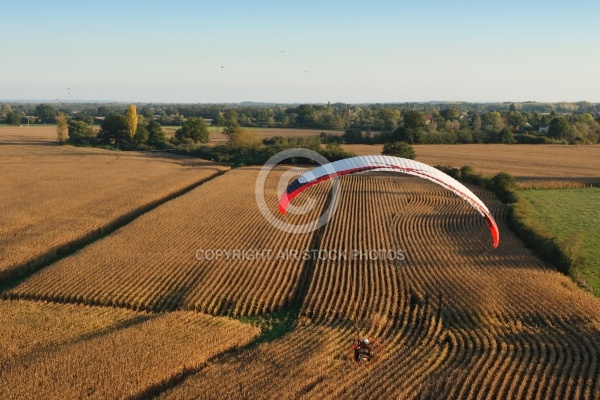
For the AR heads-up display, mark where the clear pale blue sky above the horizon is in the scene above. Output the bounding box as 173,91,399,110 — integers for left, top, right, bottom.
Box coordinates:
0,0,600,103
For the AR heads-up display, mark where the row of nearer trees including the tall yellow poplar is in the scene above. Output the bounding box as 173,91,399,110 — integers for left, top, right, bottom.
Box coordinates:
51,104,353,166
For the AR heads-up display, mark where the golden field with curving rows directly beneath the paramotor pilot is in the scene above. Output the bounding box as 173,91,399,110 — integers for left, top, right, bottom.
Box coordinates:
156,175,600,399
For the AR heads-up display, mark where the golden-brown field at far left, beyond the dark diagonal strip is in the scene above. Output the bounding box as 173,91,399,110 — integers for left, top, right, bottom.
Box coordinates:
0,138,225,281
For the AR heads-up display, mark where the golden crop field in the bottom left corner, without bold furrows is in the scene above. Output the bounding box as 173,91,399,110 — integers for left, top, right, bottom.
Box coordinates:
0,301,259,399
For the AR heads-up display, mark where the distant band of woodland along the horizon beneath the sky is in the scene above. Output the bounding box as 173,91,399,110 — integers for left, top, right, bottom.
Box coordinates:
0,102,600,144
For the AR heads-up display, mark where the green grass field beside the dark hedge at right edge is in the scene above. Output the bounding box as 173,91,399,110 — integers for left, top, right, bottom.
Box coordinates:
519,187,600,293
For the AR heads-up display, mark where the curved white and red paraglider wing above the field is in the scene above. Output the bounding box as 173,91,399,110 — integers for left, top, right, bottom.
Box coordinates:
279,155,500,248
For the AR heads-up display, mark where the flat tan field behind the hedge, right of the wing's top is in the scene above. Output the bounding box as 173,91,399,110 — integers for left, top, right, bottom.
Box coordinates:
343,144,600,186
